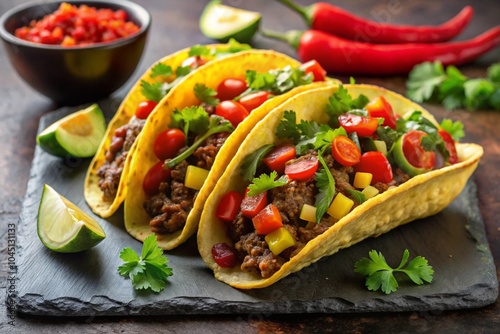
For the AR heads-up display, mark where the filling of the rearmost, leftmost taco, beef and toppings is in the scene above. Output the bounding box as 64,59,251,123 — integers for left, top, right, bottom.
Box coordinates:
97,41,249,201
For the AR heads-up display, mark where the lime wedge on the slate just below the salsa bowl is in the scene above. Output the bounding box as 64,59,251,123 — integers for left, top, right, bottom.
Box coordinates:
36,104,106,158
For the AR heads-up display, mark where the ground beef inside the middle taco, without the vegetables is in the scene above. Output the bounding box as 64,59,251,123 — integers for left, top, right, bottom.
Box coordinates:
144,133,229,234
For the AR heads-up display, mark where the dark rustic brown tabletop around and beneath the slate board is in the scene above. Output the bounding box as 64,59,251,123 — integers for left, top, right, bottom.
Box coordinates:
0,0,500,333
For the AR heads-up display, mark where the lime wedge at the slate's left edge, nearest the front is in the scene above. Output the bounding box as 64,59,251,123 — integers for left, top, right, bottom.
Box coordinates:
37,184,106,253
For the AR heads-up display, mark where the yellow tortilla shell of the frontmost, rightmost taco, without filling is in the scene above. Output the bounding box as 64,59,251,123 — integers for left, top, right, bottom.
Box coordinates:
197,85,483,289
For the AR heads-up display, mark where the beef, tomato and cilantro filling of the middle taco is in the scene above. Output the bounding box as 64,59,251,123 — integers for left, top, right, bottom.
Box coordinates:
142,64,325,234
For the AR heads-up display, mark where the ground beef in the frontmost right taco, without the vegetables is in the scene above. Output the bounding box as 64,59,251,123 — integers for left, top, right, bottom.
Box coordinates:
228,151,409,278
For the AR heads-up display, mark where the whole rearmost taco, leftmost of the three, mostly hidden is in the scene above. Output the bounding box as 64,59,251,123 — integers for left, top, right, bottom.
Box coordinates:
84,41,254,218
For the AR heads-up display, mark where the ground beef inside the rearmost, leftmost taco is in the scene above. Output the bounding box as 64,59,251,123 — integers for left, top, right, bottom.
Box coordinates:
97,117,146,202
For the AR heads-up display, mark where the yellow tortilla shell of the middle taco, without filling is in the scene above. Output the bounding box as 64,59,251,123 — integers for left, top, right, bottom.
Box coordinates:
124,50,337,250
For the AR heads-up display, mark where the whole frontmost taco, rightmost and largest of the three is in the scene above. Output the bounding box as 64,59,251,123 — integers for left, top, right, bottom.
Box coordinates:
197,85,483,289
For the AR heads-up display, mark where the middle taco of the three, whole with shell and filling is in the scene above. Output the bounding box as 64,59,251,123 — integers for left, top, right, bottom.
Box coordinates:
124,50,335,249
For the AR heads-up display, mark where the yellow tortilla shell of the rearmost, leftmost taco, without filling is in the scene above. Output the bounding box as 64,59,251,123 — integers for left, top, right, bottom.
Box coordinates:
84,44,242,218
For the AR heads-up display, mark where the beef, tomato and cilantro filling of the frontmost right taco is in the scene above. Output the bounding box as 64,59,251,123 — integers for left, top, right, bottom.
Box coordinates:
212,86,463,278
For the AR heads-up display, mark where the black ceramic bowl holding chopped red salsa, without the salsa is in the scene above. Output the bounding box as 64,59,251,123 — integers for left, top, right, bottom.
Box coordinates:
0,0,151,105
